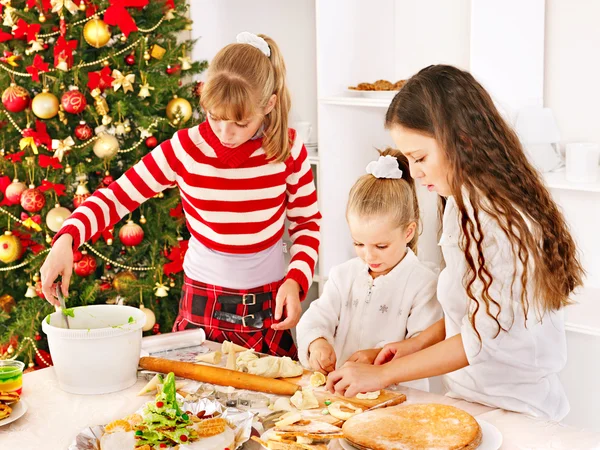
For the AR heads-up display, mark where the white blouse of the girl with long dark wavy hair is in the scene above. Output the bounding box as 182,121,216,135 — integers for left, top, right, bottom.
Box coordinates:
437,197,569,421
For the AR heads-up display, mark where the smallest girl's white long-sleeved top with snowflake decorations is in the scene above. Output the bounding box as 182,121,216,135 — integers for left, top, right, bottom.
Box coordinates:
297,249,442,390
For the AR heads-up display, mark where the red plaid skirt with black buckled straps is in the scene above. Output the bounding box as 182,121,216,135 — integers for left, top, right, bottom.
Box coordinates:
173,277,298,359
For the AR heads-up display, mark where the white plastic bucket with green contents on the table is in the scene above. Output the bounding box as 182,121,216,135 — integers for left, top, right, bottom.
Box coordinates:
42,305,146,394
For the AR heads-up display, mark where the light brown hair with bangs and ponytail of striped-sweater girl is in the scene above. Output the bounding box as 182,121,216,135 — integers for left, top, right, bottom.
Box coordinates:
200,34,292,162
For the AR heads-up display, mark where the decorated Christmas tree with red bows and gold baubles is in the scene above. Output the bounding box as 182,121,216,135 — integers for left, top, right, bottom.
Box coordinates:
0,0,206,367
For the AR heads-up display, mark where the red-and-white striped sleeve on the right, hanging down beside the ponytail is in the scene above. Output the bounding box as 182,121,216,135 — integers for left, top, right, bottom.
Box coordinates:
286,134,321,298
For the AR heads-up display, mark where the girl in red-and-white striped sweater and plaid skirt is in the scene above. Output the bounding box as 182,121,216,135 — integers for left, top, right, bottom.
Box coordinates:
41,33,321,357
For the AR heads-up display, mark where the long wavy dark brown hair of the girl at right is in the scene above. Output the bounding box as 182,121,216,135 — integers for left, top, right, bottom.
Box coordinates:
386,65,584,334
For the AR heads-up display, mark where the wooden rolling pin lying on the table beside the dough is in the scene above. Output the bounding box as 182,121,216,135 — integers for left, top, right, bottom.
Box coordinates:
140,356,300,395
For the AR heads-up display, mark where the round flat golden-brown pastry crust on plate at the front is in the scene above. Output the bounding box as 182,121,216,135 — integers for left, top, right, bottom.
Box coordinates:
343,404,482,450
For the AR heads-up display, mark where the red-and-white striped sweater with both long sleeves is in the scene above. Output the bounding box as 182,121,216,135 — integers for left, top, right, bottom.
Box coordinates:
54,122,321,293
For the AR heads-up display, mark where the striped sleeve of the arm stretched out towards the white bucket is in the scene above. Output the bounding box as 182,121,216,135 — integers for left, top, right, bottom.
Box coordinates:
53,130,187,249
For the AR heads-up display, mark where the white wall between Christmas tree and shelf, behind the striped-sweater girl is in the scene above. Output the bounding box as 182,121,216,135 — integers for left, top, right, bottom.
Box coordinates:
190,0,317,140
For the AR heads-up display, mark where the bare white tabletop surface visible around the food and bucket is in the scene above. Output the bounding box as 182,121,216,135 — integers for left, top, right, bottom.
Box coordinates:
0,343,600,450
